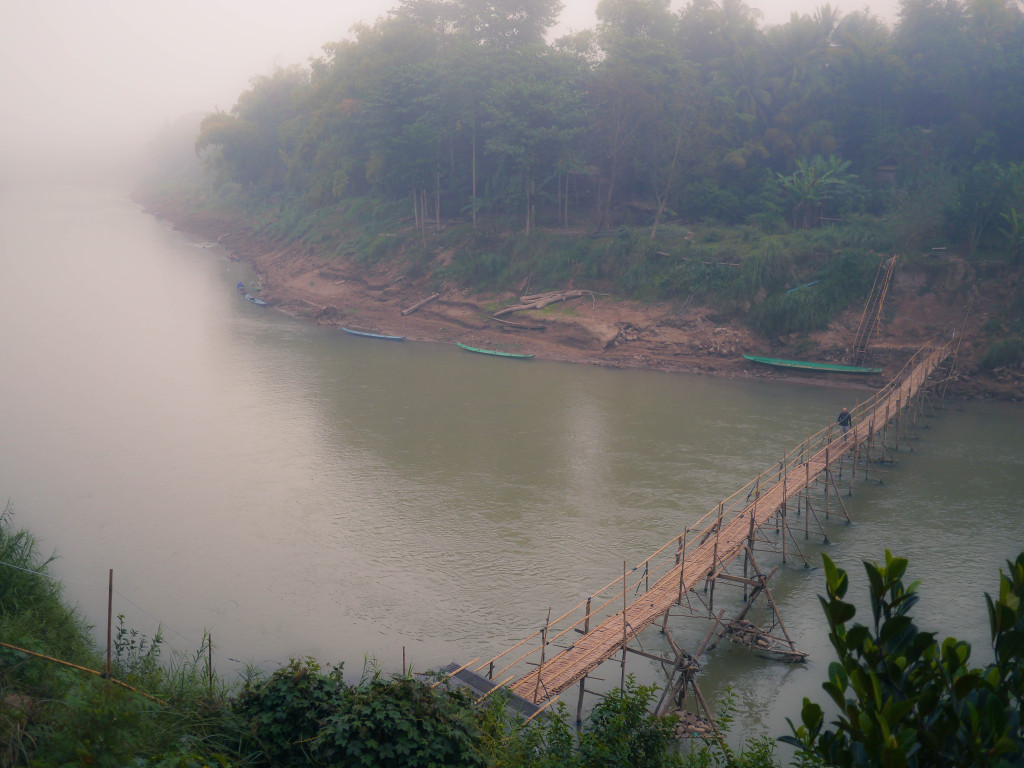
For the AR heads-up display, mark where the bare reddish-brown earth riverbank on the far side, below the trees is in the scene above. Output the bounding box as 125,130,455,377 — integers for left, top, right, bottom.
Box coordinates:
142,198,1024,401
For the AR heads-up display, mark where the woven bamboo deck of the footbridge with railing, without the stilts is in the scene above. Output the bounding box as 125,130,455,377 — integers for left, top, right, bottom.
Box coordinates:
478,345,948,703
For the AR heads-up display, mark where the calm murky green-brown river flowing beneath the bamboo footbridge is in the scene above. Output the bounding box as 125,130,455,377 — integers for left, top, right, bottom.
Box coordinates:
0,183,1024,735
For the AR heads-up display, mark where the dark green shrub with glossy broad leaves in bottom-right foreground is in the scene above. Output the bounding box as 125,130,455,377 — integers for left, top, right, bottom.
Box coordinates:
781,551,1024,768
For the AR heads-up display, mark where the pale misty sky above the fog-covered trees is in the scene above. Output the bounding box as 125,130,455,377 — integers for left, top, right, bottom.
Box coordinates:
0,0,897,171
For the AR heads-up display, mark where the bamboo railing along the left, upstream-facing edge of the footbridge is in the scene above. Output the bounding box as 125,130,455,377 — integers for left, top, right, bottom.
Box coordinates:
475,339,940,684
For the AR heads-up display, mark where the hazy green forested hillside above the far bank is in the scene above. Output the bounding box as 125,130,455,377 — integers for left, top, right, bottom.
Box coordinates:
142,0,1024,391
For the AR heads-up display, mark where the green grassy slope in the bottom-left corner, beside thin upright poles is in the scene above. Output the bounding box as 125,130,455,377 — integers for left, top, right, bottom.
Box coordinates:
0,503,238,766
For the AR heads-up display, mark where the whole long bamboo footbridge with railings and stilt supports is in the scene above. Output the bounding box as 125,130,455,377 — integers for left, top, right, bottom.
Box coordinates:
449,342,952,733
